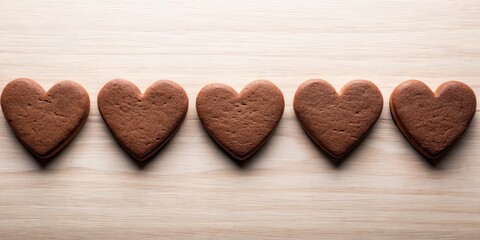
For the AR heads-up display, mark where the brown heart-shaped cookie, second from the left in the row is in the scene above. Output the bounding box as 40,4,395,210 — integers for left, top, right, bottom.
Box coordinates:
98,79,188,161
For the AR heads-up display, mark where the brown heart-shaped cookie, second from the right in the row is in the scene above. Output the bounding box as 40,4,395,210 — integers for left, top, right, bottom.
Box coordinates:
293,79,383,159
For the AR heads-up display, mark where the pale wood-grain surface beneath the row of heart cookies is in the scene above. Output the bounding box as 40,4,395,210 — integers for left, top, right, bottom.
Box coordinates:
0,0,480,239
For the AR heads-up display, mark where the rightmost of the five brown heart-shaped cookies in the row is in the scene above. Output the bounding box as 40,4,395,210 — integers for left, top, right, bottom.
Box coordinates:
390,80,477,159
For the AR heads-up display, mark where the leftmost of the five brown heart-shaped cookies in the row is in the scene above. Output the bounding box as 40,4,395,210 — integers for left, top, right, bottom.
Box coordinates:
1,78,90,159
